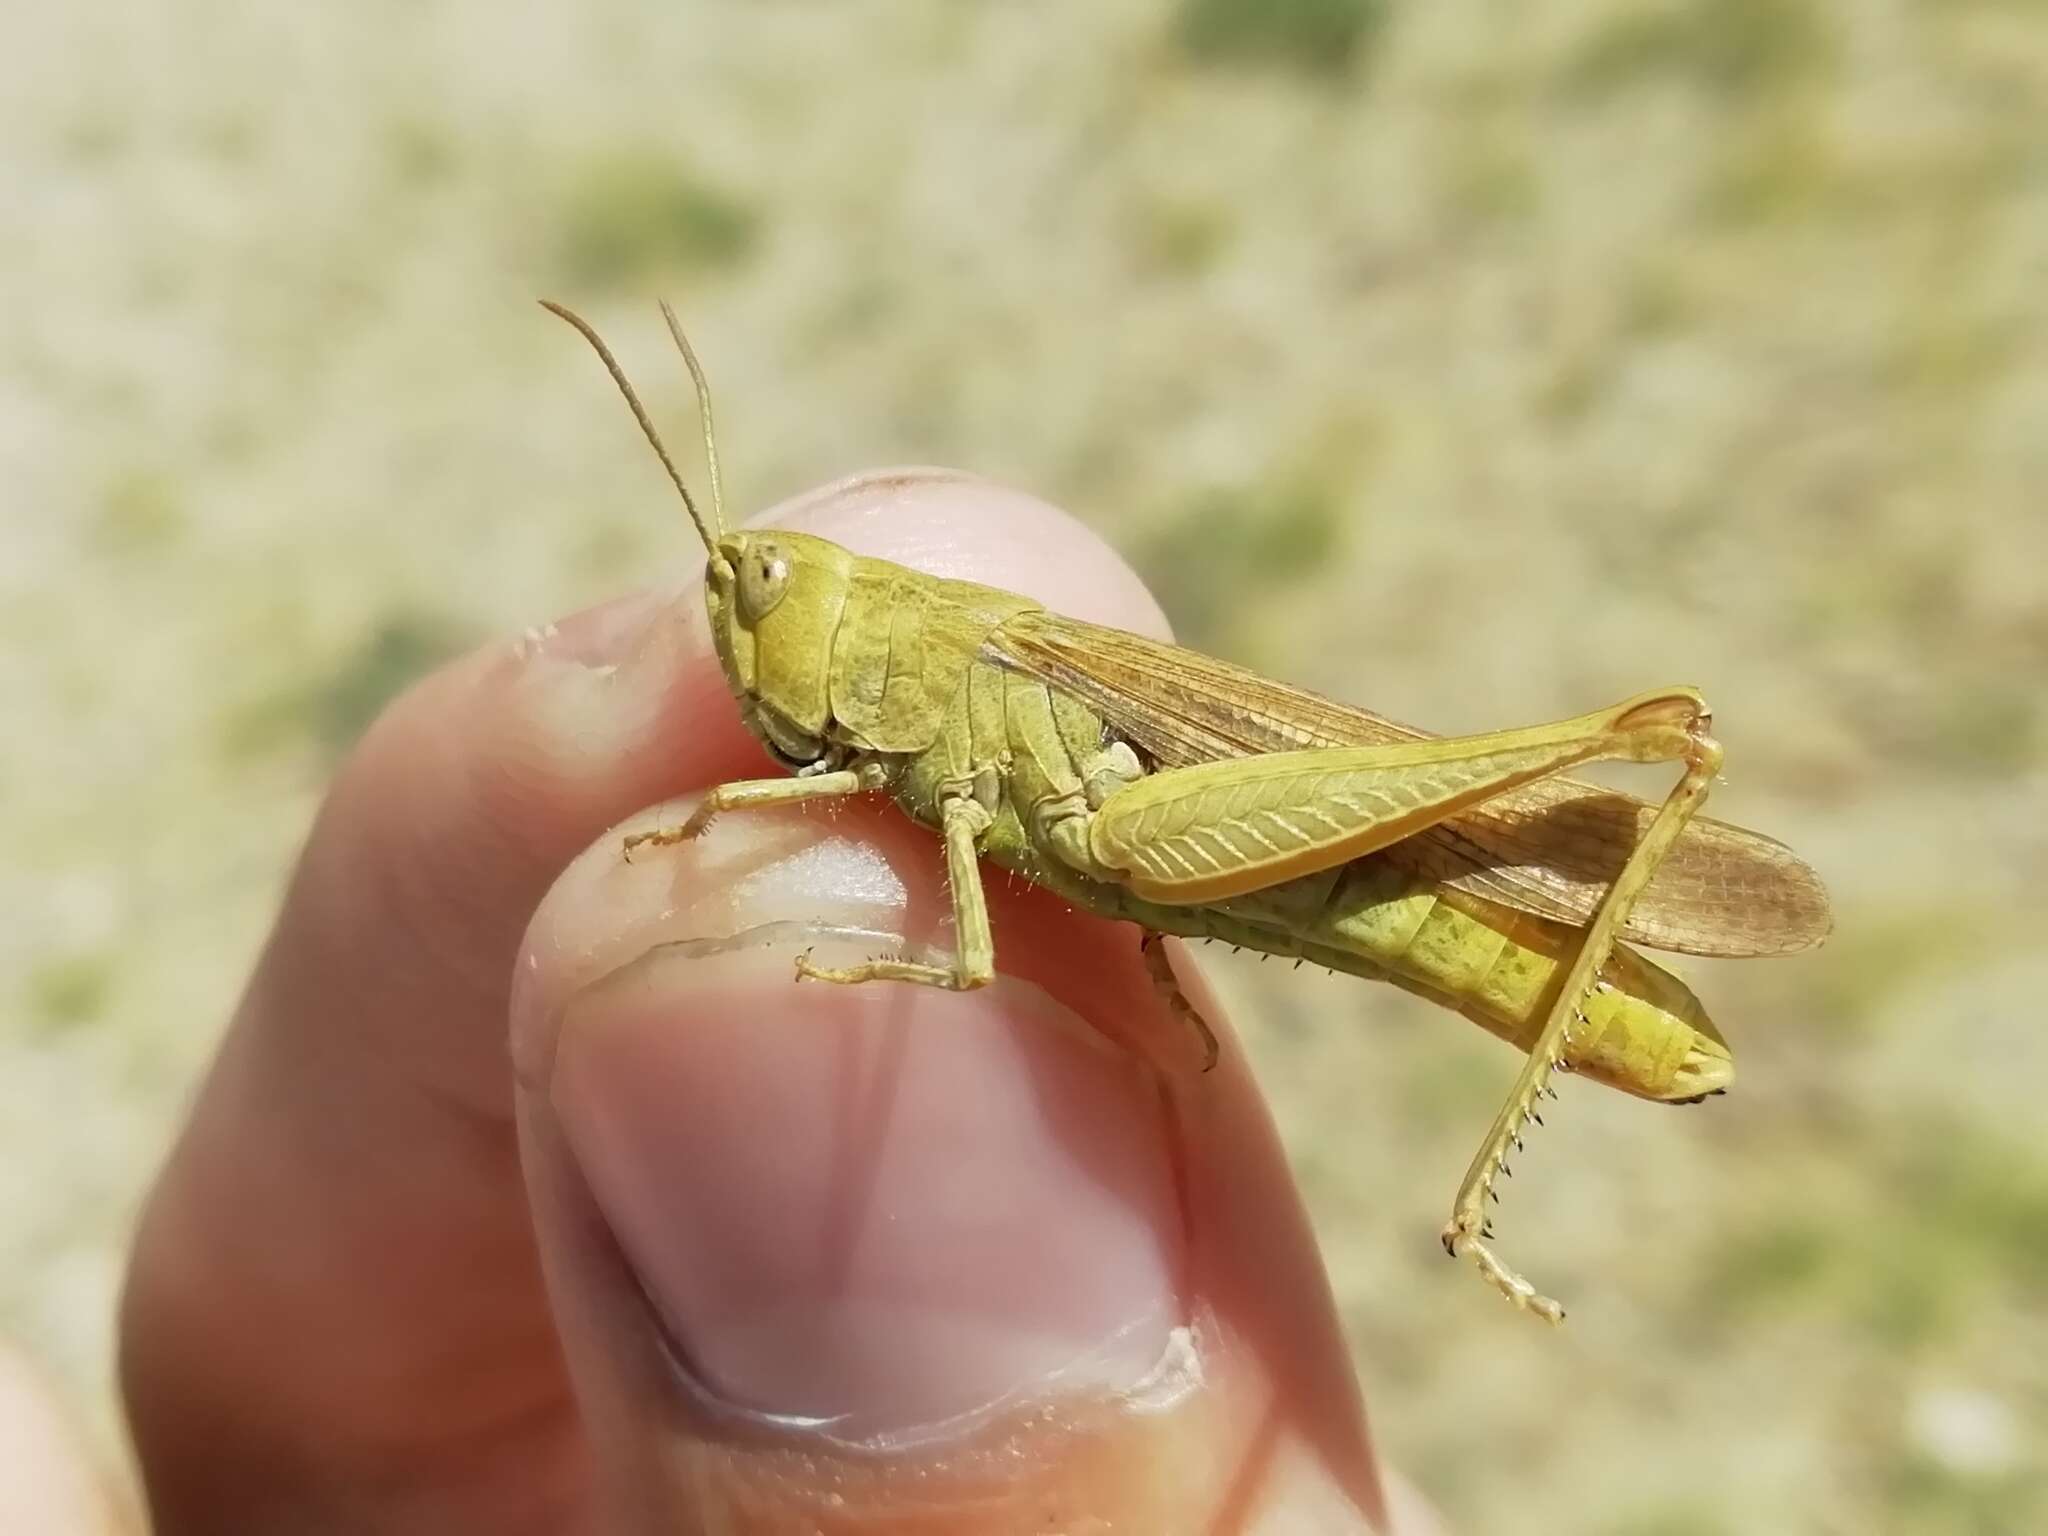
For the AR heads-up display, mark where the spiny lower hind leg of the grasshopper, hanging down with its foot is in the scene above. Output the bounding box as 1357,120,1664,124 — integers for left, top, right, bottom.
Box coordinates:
1444,707,1720,1323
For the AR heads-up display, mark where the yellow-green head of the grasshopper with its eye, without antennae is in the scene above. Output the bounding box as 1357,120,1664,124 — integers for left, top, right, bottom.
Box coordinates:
705,530,854,768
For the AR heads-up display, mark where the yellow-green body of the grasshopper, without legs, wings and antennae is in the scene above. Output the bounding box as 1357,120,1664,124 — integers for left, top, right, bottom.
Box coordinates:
715,532,1733,1100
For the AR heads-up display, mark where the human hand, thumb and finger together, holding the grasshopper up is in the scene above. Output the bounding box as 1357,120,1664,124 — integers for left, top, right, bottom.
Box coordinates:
123,471,1386,1536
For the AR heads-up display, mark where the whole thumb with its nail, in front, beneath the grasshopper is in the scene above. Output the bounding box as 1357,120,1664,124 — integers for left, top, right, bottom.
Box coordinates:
512,786,1382,1534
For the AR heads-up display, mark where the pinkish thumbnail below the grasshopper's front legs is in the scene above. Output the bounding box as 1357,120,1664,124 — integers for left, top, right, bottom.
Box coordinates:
549,872,1188,1444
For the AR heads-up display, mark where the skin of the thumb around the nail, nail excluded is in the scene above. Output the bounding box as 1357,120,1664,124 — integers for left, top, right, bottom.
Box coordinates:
514,753,1384,1507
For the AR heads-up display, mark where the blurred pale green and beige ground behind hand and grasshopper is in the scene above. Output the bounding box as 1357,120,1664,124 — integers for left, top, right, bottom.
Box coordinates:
0,0,2048,1536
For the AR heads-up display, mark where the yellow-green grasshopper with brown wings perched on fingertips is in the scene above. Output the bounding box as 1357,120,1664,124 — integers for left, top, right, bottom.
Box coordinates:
543,301,1829,1323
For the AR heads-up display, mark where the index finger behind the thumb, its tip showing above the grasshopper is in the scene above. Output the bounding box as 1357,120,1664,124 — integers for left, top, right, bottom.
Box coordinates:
123,471,1310,1530
